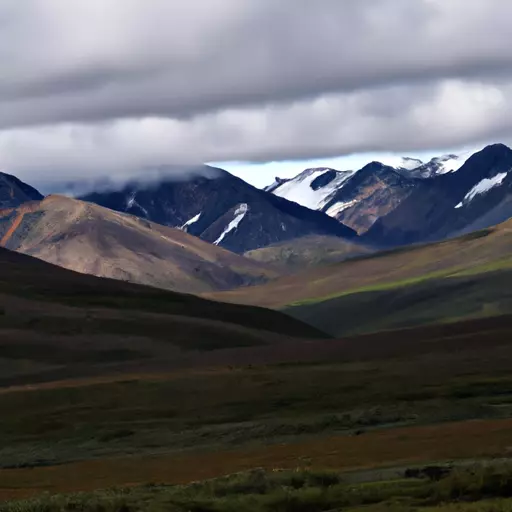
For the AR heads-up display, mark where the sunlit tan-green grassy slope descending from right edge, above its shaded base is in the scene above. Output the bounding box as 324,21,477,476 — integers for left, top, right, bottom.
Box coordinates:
211,221,512,309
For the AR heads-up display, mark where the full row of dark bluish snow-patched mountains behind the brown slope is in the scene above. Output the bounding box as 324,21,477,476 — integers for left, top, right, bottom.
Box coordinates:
4,144,512,260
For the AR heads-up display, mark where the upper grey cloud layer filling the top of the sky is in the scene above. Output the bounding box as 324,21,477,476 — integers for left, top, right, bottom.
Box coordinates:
0,0,512,128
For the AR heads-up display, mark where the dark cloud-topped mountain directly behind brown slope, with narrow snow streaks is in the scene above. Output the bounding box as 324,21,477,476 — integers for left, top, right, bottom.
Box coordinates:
82,168,355,253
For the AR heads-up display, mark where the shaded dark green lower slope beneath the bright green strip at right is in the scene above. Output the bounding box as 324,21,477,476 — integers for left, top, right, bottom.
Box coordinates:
285,268,512,337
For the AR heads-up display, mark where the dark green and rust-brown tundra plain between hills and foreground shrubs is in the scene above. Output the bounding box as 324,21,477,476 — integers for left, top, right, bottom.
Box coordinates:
0,318,512,500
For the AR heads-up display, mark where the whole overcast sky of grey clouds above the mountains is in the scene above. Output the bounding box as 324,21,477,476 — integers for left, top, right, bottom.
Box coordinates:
0,0,512,189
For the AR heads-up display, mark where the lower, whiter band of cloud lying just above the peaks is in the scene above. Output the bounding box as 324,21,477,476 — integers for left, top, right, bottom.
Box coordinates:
0,80,512,191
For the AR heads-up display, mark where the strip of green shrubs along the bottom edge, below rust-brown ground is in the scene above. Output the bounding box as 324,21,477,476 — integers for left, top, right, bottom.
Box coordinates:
7,465,512,512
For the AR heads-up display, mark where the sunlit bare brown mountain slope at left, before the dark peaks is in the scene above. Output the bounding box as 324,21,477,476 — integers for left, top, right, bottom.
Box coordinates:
0,196,277,293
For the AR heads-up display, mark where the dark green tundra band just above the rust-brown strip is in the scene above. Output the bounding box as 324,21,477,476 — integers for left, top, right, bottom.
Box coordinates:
5,325,512,468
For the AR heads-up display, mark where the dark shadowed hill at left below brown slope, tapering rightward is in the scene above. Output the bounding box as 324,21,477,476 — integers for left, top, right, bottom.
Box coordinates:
0,243,325,385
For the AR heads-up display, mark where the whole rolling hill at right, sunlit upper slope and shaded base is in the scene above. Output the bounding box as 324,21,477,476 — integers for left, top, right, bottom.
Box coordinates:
210,221,512,336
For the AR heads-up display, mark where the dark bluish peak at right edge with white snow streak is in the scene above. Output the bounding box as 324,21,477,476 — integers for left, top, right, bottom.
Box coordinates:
365,144,512,245
